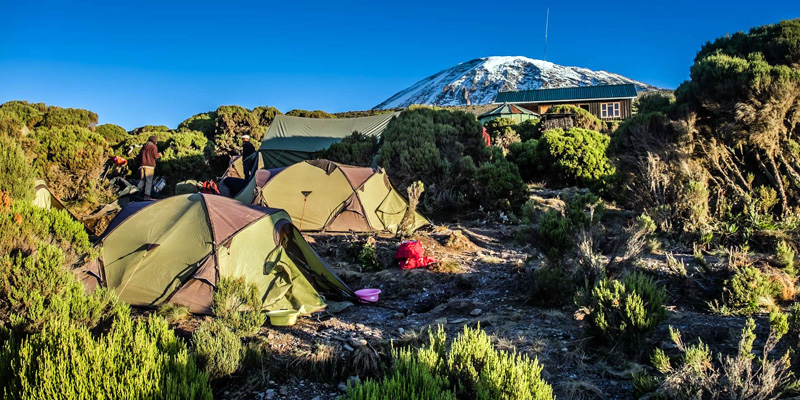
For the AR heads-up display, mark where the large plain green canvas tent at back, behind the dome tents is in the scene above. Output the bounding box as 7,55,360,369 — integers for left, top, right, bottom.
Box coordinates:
258,112,400,169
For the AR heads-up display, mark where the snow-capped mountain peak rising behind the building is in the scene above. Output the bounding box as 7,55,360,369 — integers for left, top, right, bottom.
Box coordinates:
375,56,656,109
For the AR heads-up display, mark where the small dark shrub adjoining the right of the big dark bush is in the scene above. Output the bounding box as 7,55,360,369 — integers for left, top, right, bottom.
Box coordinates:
475,154,528,211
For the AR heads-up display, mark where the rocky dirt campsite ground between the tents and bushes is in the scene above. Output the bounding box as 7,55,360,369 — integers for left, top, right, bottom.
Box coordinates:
159,190,780,400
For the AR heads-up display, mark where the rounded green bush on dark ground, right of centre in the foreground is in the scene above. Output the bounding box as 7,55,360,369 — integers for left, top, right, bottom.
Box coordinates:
583,272,667,346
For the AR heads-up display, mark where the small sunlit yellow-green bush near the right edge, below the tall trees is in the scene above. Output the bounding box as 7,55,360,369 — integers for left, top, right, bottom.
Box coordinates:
720,266,781,315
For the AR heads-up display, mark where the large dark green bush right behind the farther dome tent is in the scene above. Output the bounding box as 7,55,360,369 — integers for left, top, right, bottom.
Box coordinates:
380,108,488,213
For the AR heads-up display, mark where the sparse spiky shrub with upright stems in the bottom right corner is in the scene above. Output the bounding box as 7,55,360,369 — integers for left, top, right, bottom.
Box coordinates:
637,313,799,400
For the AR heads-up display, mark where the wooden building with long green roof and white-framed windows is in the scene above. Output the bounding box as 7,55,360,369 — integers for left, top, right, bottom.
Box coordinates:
494,84,637,120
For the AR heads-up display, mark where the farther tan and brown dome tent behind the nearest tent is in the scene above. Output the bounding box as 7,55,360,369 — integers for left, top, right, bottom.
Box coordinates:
236,160,430,233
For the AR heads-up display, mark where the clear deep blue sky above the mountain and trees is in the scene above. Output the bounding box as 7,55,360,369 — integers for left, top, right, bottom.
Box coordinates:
0,0,800,129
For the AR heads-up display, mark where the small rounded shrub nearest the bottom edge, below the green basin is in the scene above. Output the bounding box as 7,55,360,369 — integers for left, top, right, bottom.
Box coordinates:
192,320,242,379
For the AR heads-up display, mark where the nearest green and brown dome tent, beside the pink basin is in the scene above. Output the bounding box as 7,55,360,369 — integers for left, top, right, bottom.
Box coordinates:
82,193,355,314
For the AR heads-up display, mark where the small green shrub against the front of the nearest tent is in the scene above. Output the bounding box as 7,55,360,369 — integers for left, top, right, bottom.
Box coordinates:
213,277,266,336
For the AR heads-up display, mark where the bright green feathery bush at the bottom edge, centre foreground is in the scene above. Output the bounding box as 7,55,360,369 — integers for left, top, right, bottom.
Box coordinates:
344,326,554,400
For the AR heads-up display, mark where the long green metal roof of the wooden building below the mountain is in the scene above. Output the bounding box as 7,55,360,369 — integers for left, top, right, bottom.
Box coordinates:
494,83,636,103
